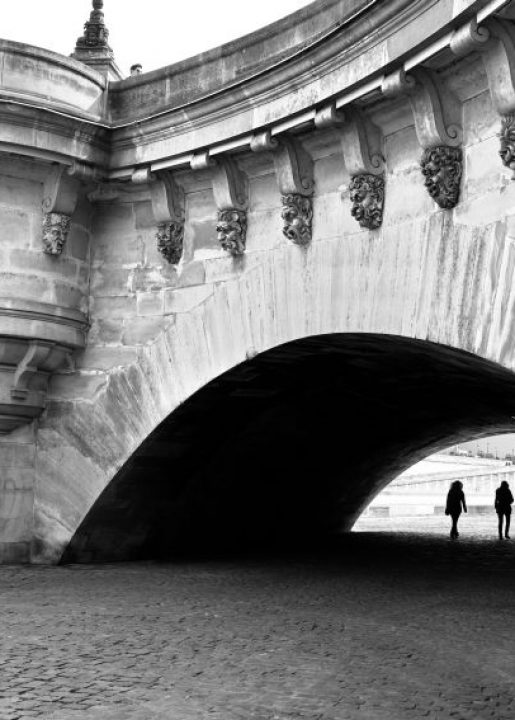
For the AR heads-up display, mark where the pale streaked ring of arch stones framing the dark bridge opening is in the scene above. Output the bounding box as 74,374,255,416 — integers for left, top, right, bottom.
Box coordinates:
32,201,514,562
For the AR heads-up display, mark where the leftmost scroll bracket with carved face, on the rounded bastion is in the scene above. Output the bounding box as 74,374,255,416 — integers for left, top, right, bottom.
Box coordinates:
43,165,80,255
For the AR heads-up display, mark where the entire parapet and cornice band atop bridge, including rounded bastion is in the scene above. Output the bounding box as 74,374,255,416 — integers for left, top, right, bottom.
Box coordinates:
0,0,507,180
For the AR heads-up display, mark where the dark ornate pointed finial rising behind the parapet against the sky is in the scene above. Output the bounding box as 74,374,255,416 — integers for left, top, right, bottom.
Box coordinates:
72,0,123,80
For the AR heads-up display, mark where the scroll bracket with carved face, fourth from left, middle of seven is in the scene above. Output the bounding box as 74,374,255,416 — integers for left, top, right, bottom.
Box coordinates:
250,131,315,245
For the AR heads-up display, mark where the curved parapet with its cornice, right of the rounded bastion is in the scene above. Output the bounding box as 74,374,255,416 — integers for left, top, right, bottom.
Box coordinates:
109,0,493,177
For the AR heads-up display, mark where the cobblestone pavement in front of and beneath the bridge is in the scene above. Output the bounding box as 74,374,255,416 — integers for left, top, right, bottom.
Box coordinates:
0,533,515,720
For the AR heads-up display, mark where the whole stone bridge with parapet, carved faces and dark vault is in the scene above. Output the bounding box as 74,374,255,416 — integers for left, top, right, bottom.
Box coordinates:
0,0,515,563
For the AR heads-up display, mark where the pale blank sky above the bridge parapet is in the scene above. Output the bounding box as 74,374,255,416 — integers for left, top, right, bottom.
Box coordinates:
0,0,310,74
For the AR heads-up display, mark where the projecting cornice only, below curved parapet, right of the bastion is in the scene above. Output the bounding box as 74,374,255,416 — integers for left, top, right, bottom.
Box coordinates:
111,0,501,177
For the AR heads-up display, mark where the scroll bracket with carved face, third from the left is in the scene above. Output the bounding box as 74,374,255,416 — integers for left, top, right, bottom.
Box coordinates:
190,152,248,257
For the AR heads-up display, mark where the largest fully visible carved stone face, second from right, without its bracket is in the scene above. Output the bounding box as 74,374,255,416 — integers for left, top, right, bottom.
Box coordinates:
420,145,463,210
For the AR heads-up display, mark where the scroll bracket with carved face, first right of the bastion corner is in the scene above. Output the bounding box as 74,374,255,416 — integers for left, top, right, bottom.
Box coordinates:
140,170,184,265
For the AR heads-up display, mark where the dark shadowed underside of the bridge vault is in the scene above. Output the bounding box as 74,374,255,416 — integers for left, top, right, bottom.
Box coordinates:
63,334,515,561
